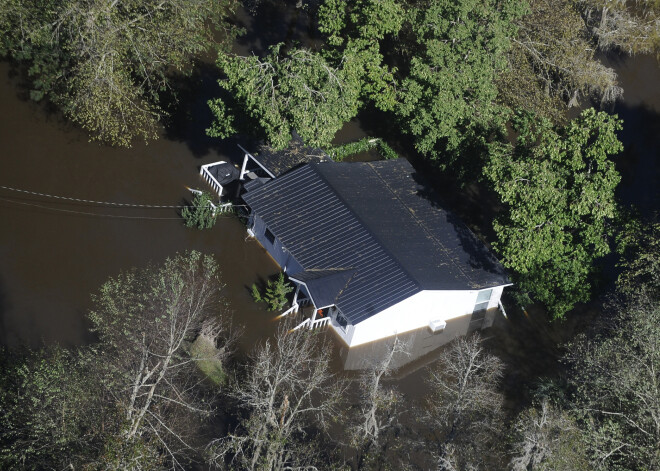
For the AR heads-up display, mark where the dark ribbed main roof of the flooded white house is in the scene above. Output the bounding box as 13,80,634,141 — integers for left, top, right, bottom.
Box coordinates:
244,159,509,324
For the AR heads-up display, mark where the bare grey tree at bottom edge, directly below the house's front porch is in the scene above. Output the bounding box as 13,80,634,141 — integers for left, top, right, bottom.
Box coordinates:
209,323,344,471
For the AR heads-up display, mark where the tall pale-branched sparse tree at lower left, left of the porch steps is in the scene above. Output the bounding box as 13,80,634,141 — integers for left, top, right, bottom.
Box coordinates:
89,252,228,469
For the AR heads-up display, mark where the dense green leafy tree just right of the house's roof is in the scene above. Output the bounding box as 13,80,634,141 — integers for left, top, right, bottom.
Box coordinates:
485,109,622,318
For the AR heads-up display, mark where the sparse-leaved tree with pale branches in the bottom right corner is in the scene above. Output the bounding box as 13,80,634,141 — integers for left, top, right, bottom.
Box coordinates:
566,294,660,470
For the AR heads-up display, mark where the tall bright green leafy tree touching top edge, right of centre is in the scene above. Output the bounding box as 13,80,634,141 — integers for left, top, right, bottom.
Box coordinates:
396,0,522,165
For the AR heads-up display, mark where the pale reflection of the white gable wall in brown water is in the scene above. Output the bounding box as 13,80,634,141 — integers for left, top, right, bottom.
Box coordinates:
339,309,500,377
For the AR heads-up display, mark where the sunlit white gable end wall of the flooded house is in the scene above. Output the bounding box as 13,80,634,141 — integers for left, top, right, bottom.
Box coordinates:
333,286,504,347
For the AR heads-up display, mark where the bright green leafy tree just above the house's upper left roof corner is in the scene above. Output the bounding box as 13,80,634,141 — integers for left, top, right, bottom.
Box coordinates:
207,44,361,149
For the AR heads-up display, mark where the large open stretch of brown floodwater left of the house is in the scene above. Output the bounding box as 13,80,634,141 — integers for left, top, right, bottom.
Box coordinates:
0,60,286,346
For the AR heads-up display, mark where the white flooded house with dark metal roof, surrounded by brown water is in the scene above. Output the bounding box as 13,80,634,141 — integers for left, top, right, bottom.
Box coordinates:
201,140,511,347
